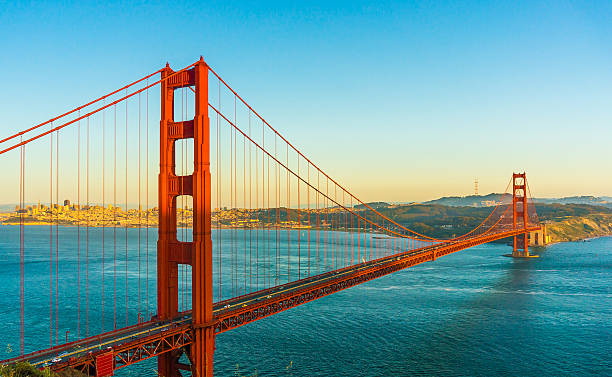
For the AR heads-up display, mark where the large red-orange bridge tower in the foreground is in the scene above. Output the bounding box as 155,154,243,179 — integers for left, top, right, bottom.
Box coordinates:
157,58,215,377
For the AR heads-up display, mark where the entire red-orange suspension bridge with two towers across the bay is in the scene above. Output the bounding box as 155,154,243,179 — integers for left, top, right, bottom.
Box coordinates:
0,58,540,377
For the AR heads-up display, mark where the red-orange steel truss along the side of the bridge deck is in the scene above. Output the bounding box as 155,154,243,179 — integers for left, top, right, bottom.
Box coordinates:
46,227,540,375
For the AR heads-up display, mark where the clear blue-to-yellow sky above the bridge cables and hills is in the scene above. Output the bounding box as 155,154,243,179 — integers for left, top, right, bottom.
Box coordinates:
0,1,612,202
